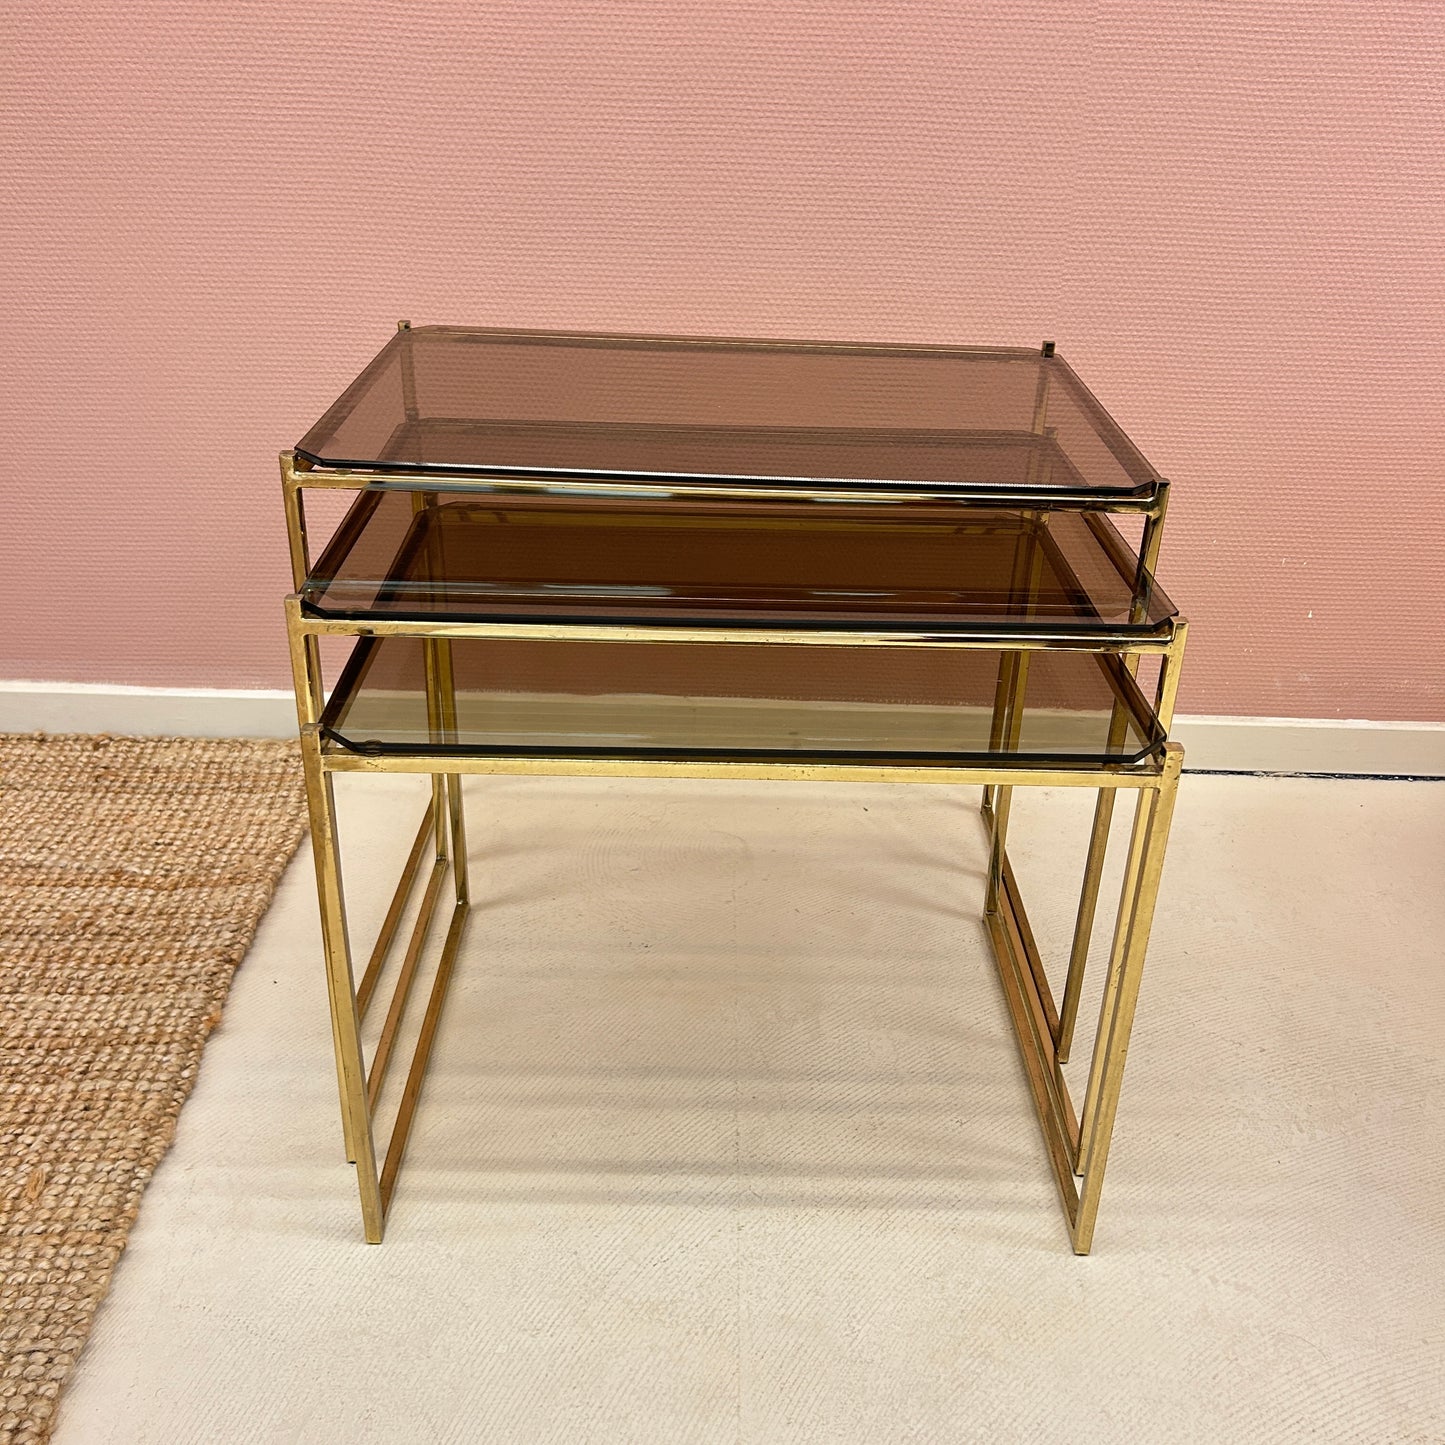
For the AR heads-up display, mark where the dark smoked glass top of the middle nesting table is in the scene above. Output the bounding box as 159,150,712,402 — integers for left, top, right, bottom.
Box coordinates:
302,491,1175,636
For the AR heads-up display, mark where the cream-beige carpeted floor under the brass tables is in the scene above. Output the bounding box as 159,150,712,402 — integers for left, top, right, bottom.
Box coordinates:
36,776,1445,1445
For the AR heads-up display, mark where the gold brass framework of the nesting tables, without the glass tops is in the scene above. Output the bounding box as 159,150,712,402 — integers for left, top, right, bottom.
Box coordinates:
280,387,1188,1254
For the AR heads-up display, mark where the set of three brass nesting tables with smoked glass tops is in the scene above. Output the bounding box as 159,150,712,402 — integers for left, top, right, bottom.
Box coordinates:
282,322,1186,1254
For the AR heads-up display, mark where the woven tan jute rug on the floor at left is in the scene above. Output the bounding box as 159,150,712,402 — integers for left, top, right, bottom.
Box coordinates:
0,734,305,1445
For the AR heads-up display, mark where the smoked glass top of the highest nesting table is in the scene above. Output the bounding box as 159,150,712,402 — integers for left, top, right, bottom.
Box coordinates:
296,327,1157,500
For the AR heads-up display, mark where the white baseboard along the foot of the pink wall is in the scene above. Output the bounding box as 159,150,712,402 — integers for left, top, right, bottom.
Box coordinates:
0,681,1445,777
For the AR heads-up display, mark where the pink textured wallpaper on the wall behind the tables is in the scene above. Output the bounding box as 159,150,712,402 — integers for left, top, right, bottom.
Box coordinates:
0,0,1445,720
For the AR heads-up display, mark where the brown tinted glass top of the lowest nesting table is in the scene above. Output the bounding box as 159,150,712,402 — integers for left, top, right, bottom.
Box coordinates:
322,637,1162,764
